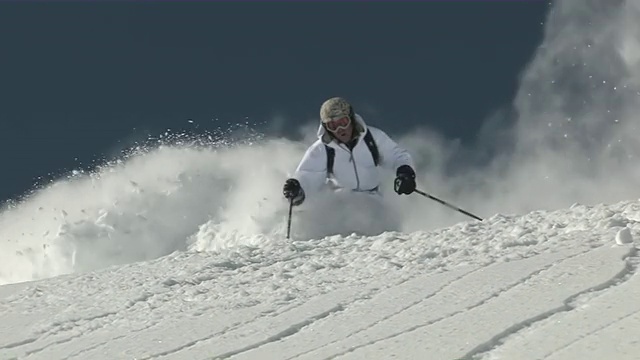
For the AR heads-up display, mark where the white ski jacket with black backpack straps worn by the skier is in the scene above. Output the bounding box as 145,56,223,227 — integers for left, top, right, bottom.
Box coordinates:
293,114,415,197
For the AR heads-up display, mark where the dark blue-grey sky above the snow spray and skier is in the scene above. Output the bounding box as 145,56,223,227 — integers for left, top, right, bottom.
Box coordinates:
0,1,549,200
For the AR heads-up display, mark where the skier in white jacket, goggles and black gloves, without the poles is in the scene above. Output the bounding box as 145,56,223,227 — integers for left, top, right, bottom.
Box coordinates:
283,97,416,206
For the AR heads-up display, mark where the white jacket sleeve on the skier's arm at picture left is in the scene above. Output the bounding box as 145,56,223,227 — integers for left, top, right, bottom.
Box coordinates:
293,141,327,194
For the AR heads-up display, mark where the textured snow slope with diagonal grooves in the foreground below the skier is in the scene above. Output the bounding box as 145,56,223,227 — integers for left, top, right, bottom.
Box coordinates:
0,198,640,360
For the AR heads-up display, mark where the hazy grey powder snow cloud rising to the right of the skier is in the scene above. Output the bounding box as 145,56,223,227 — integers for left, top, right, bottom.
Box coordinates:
388,0,640,228
